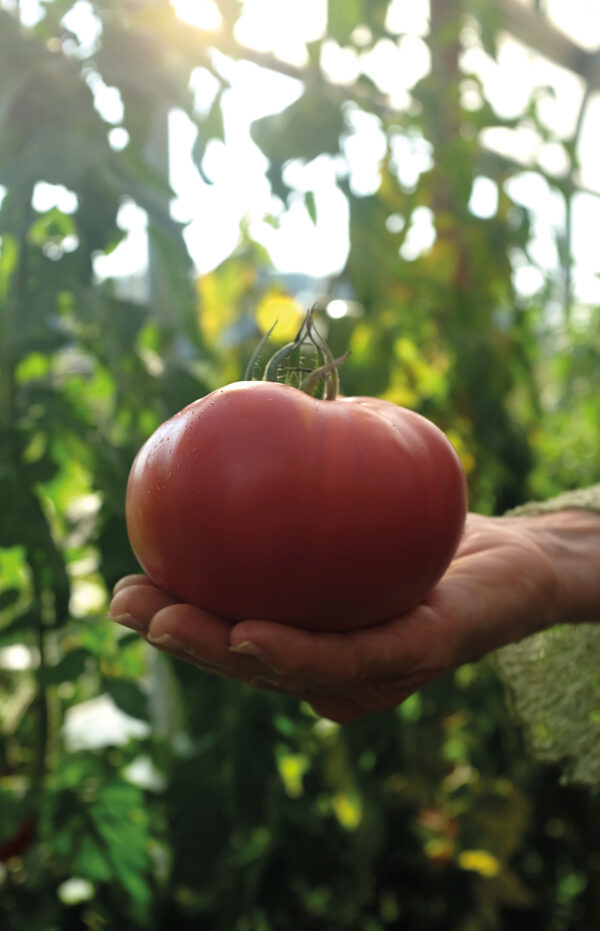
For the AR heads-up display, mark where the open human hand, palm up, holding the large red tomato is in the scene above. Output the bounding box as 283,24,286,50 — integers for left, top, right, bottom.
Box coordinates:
110,514,580,723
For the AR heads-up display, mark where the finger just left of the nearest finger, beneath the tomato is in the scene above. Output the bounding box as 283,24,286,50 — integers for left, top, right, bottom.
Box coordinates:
147,603,268,680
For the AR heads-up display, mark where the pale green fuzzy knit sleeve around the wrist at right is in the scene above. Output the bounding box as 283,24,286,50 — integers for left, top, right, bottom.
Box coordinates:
494,485,600,787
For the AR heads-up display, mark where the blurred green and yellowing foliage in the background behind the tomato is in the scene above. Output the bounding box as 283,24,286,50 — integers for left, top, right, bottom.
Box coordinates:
0,0,600,931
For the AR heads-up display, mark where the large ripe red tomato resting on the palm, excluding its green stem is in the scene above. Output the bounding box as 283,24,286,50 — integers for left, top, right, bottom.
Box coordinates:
126,382,467,631
